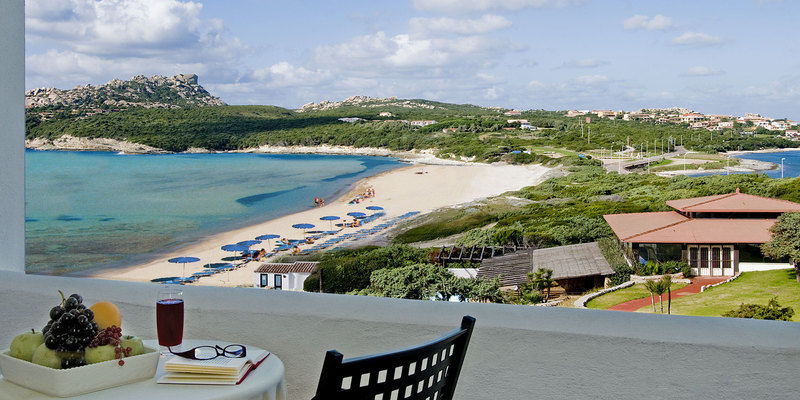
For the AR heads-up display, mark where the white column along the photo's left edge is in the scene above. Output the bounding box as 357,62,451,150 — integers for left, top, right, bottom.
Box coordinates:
0,0,25,273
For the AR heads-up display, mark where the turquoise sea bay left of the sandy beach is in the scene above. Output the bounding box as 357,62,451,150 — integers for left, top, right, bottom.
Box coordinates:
25,150,402,274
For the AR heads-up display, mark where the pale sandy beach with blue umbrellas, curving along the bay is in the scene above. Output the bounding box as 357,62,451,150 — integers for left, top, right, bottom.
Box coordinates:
97,163,552,286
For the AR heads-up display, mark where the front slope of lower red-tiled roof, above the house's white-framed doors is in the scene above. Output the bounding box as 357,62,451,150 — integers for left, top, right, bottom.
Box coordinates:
621,218,775,243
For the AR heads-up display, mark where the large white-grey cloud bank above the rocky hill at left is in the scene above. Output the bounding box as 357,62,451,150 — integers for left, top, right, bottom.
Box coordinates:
25,0,248,87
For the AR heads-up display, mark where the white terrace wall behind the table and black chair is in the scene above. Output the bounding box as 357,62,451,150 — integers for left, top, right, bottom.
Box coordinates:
0,272,800,400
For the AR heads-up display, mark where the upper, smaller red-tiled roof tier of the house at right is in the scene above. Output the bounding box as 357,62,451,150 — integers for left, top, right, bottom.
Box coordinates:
667,189,800,213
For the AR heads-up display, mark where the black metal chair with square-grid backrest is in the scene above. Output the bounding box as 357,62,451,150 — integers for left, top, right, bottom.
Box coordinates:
314,316,475,400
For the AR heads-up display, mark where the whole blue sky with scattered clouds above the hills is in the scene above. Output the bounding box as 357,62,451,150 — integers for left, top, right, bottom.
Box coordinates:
21,0,800,119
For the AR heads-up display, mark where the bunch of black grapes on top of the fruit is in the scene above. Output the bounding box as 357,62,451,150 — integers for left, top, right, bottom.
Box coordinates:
42,291,97,352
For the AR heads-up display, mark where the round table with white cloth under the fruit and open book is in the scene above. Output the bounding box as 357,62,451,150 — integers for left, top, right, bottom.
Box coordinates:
0,340,287,400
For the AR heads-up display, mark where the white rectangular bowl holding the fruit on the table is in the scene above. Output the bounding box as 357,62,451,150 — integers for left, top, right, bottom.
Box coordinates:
0,346,159,397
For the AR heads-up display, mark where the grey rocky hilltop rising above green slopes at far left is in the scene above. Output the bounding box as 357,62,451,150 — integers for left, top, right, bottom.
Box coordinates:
25,74,225,110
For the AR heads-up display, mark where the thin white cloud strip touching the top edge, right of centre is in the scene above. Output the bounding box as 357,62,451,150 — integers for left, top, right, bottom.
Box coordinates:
414,0,583,14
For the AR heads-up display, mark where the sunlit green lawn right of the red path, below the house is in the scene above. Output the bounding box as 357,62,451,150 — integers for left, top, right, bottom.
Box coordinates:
636,269,800,321
